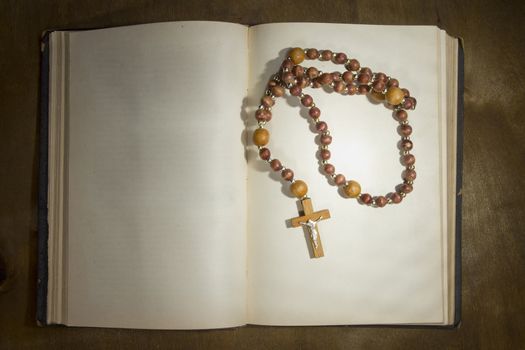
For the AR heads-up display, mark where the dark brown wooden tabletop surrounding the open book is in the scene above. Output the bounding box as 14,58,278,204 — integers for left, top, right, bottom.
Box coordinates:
0,0,525,349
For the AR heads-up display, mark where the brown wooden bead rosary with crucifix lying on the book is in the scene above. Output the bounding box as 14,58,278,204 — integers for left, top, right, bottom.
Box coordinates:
253,47,416,258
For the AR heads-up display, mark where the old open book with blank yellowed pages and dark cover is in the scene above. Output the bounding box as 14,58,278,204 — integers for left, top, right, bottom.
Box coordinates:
38,22,462,329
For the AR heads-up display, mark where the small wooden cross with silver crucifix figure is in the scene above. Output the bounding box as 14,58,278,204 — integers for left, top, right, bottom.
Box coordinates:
291,197,330,258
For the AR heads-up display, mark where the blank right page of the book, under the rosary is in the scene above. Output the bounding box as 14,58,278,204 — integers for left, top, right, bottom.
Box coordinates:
248,23,448,325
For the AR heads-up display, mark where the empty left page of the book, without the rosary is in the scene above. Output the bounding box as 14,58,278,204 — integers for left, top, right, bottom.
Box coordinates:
65,22,248,329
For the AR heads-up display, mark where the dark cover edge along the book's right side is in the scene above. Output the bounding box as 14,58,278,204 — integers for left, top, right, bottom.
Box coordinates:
454,39,465,327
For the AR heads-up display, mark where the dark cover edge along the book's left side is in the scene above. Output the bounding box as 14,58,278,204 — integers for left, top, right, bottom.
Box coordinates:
36,32,50,326
